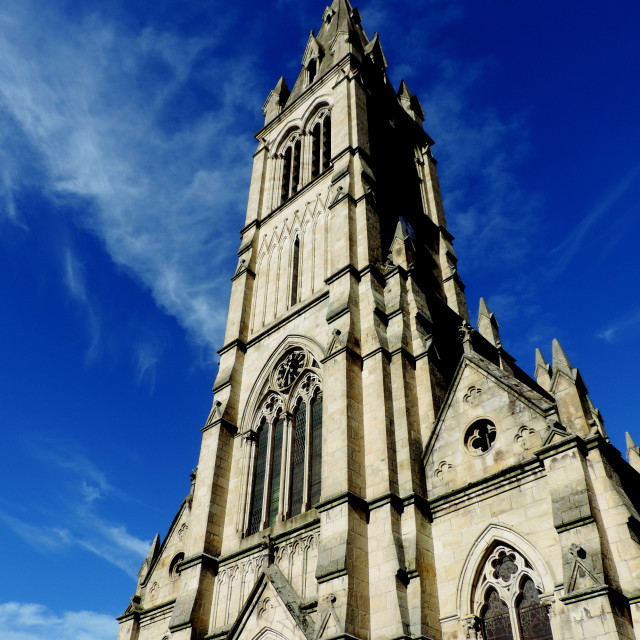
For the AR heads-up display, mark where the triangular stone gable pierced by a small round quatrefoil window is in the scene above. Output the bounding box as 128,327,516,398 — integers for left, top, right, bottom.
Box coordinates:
425,355,555,497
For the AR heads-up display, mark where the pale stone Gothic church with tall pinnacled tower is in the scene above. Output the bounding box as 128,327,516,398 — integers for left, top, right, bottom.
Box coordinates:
118,0,640,640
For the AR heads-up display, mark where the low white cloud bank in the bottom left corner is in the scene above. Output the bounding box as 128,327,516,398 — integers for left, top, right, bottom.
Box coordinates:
0,602,118,640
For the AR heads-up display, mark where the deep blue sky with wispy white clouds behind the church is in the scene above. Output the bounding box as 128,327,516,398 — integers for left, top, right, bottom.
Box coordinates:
0,0,640,640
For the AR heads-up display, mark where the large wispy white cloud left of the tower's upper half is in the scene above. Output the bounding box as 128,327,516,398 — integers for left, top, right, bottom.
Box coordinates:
0,0,259,360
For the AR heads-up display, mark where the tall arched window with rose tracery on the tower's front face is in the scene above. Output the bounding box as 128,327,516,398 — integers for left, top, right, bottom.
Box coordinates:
244,348,322,535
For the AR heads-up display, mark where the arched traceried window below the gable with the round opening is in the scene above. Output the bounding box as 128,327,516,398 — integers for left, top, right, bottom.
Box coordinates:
476,546,553,640
